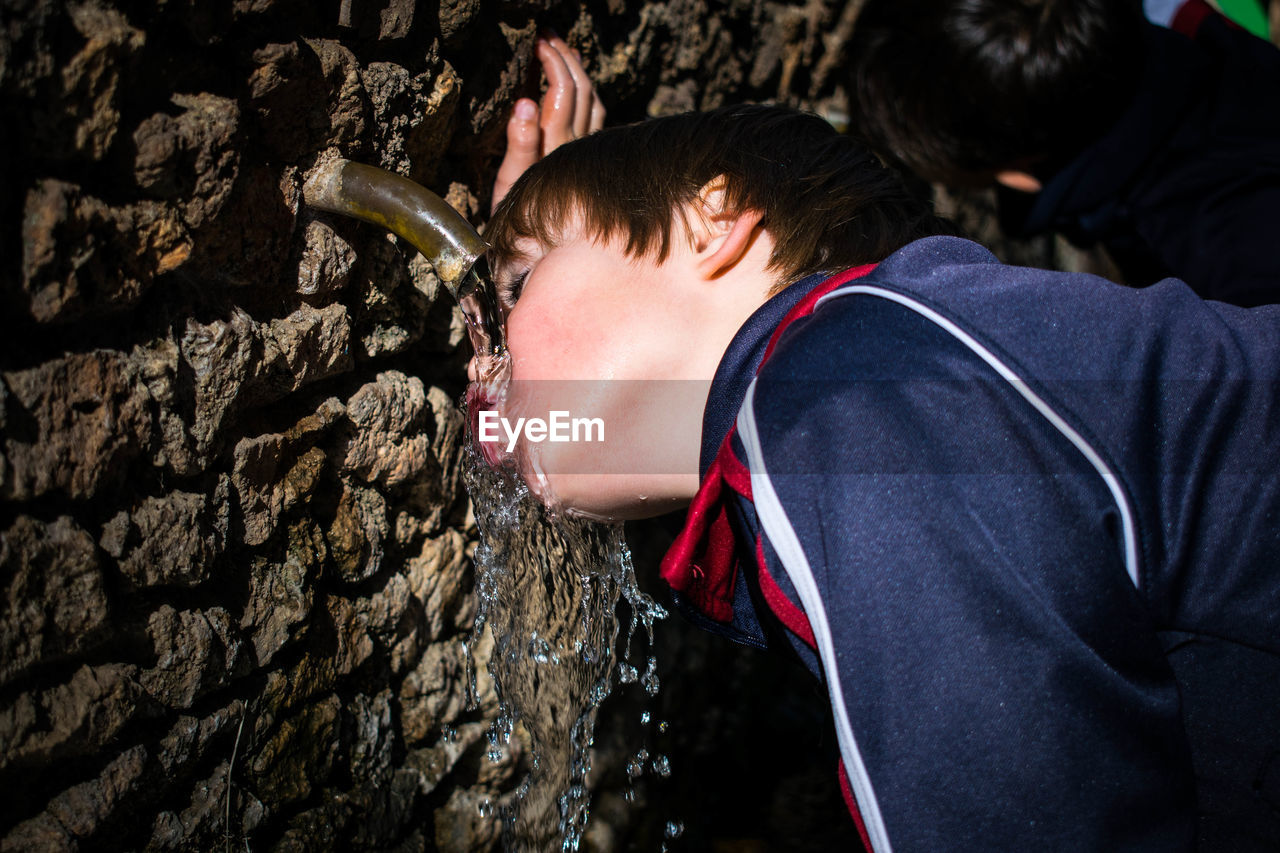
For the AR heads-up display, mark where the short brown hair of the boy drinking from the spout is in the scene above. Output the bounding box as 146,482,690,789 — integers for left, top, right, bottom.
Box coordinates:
485,105,957,289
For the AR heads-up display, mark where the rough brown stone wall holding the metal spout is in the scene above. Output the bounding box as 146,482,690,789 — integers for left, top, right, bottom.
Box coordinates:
0,0,856,850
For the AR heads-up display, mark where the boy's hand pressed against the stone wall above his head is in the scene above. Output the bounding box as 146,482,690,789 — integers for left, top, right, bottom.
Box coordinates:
490,36,604,210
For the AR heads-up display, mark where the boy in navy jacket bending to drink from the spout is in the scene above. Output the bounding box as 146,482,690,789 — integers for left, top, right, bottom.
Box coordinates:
486,106,1280,852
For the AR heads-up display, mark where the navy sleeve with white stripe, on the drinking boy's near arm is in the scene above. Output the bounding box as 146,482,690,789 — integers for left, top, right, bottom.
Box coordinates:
739,294,1194,852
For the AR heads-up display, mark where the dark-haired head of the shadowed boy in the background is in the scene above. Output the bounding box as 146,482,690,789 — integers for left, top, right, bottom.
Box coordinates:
850,0,1144,186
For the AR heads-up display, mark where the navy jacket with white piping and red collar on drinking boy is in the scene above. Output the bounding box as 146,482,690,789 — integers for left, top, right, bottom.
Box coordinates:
663,237,1280,852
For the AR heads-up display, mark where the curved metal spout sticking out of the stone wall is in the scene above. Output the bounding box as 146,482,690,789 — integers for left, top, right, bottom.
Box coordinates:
302,160,506,356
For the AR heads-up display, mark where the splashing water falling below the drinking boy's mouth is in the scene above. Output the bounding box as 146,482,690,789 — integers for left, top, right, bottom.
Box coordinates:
465,409,666,852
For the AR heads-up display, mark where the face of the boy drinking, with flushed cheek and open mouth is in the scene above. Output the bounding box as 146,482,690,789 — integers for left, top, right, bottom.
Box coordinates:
480,216,718,519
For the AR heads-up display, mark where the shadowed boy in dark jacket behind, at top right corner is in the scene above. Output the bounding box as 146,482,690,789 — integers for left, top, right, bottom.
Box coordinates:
850,0,1280,305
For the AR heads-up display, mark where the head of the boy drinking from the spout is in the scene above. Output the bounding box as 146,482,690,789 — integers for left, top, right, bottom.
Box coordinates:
481,106,954,517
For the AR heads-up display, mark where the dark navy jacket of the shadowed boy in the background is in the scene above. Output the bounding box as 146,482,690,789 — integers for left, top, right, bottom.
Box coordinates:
1000,4,1280,305
